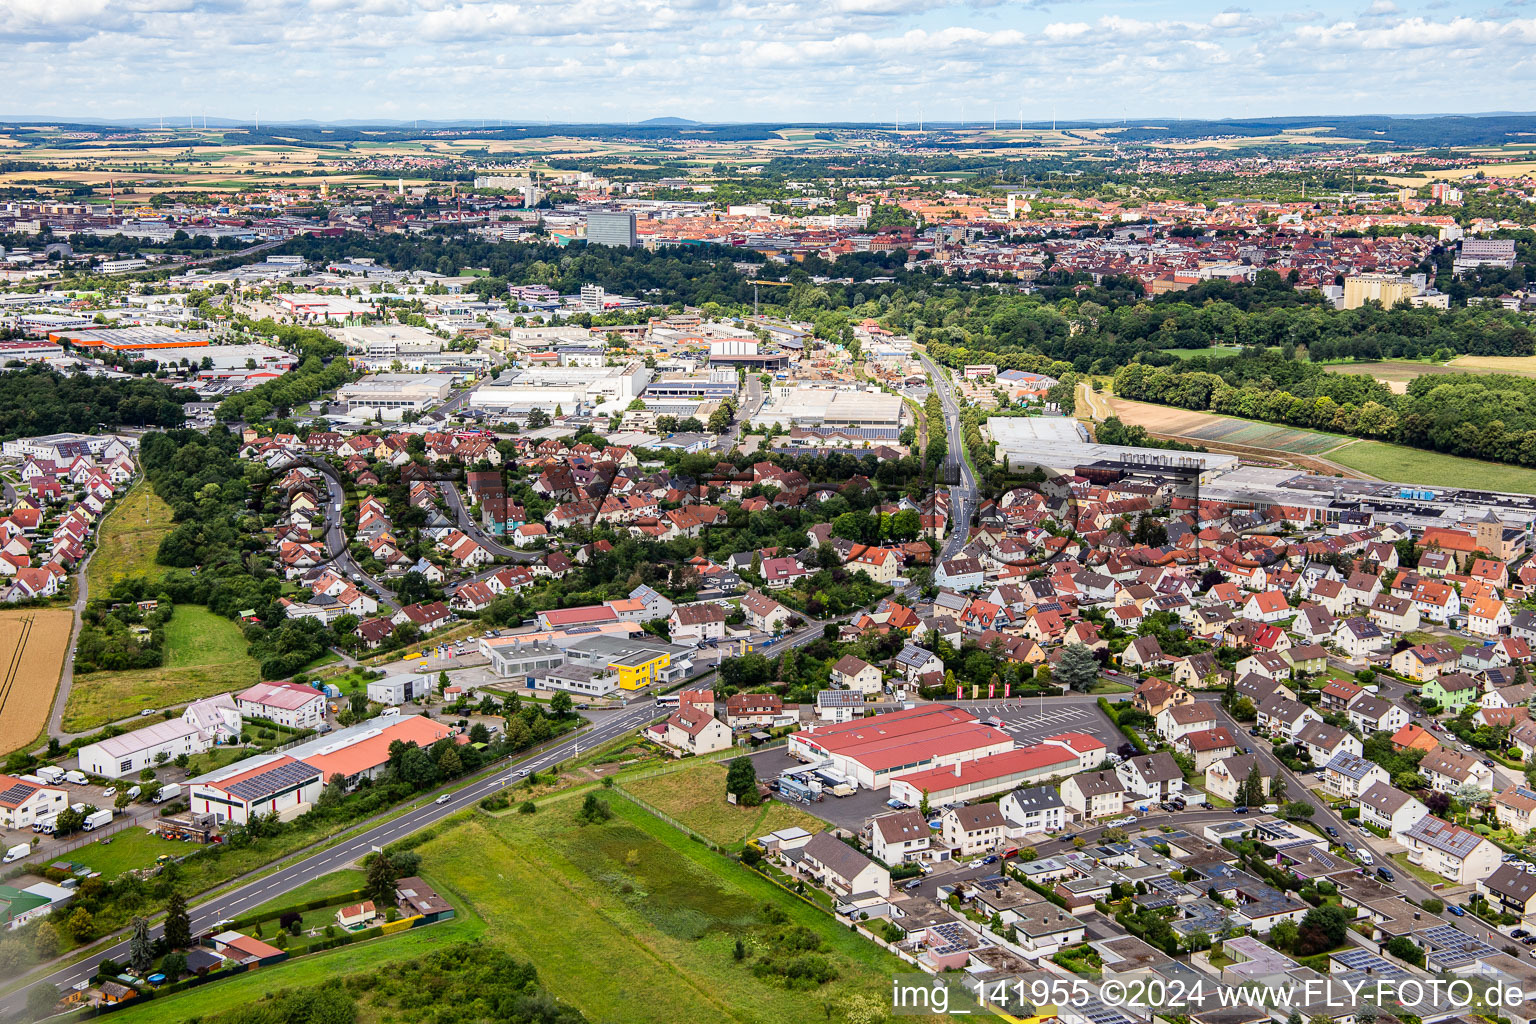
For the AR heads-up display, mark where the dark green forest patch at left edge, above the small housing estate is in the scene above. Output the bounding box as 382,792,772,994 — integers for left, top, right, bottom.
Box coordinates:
0,364,188,441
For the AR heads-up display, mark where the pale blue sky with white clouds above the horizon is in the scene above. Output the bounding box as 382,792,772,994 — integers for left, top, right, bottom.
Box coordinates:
0,0,1536,123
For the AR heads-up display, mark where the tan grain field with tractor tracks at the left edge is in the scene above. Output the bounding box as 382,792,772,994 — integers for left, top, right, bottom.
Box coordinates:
0,608,75,754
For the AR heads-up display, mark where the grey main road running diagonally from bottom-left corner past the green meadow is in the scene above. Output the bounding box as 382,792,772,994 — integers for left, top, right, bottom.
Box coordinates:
0,699,657,1018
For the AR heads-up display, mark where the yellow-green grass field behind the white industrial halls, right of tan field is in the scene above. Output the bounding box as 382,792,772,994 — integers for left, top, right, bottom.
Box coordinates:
65,605,258,732
